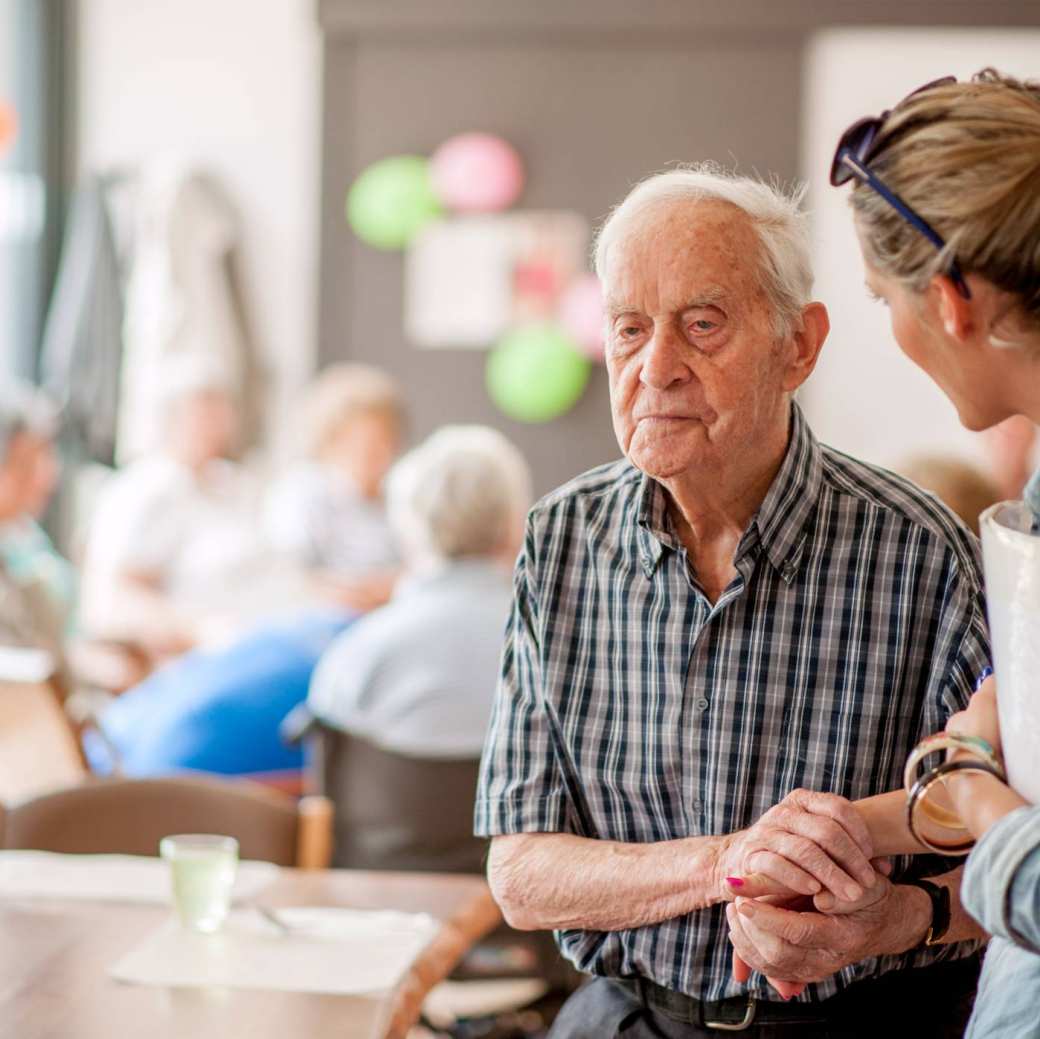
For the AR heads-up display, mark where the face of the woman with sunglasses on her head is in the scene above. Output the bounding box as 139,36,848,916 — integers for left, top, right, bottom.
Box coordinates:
860,229,1012,430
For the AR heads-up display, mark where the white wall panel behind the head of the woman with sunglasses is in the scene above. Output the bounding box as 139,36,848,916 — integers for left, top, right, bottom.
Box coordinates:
803,29,1040,474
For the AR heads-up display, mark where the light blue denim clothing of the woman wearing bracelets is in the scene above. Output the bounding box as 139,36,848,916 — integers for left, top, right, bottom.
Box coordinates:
961,806,1040,1039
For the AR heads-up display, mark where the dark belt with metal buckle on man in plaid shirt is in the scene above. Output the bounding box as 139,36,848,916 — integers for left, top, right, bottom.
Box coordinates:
614,955,980,1032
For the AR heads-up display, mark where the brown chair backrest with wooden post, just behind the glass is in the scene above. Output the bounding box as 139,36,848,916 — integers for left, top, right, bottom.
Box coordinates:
0,776,333,869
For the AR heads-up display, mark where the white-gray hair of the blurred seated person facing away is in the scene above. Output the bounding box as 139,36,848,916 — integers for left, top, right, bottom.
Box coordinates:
386,425,531,565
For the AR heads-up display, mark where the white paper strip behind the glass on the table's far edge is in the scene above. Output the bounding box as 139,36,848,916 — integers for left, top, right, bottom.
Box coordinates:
0,851,279,903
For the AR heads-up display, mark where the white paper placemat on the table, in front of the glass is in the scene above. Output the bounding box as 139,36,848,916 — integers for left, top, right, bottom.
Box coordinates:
108,907,439,995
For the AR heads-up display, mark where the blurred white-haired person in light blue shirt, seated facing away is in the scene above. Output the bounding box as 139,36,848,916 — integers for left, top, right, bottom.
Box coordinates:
308,426,530,761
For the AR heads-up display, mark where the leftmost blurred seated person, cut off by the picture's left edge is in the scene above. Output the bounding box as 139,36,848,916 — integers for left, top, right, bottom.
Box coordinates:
0,380,144,690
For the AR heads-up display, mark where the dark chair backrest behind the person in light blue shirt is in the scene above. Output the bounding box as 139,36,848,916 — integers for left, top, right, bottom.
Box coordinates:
310,725,487,874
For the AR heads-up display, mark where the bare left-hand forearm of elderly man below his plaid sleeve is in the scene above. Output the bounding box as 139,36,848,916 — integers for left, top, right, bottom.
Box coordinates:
488,833,725,931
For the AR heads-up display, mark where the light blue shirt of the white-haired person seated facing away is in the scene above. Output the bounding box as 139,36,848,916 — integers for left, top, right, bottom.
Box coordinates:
308,560,513,758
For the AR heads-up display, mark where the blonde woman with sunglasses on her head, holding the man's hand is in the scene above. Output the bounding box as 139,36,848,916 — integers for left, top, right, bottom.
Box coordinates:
736,70,1040,1039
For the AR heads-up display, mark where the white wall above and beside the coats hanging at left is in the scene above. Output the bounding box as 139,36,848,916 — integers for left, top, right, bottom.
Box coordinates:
76,0,320,459
